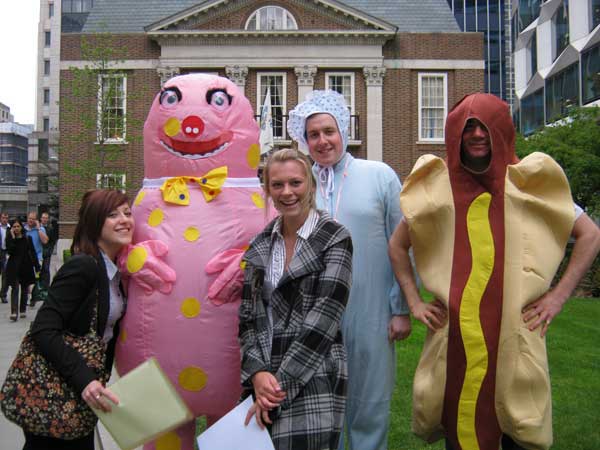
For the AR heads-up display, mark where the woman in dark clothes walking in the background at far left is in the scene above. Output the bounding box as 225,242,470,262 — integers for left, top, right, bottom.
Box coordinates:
6,219,39,322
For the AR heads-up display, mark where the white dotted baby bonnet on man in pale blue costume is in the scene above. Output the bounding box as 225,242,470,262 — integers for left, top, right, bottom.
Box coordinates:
287,90,350,156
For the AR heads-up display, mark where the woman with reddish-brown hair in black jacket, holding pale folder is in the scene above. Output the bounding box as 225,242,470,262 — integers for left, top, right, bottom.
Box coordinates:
23,190,134,450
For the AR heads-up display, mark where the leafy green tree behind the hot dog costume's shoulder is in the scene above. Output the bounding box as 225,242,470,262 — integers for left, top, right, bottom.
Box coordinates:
516,107,600,218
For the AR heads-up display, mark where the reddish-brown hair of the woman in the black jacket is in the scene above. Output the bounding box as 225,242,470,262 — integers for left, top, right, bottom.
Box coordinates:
71,189,129,256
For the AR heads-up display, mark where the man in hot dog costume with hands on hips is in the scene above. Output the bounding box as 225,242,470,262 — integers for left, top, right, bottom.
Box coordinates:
390,94,600,450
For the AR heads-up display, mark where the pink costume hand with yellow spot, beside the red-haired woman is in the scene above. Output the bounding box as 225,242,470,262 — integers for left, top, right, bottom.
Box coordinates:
118,240,176,295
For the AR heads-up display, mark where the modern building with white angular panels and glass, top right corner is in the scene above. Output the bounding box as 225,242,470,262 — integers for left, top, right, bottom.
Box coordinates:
511,0,600,135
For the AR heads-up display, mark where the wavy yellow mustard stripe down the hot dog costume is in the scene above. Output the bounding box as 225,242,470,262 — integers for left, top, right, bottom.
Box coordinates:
457,192,494,450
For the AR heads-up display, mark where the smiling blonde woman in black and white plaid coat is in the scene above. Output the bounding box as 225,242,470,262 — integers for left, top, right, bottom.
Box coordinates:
239,149,352,450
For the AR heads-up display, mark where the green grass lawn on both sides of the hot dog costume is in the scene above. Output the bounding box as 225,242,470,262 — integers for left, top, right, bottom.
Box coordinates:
389,299,600,450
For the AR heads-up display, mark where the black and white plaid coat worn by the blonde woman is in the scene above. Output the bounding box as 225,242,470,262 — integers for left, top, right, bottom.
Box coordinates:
239,211,352,450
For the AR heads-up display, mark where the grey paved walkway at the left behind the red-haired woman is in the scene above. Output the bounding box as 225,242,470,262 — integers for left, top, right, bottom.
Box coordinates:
0,256,132,450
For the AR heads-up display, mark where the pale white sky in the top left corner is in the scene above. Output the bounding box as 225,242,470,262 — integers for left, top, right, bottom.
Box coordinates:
0,0,40,124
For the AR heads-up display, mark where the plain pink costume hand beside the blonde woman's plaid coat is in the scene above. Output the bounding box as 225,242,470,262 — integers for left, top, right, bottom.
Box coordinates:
205,248,245,305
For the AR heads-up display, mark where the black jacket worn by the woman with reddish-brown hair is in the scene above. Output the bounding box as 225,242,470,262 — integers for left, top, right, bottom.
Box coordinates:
31,254,119,394
